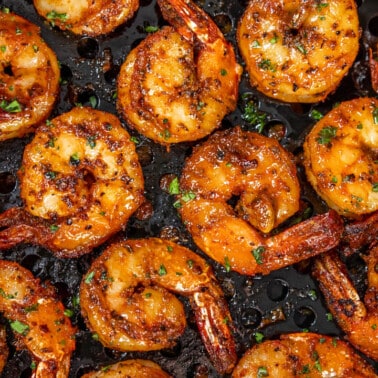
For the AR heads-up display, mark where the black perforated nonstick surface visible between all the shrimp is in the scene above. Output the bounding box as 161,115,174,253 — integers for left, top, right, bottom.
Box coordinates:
0,0,378,377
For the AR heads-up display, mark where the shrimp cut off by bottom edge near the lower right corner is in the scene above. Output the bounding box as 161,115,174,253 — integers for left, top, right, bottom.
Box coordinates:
232,333,377,378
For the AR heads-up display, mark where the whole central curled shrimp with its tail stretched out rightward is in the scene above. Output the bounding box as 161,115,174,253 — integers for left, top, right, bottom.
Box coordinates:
177,127,343,275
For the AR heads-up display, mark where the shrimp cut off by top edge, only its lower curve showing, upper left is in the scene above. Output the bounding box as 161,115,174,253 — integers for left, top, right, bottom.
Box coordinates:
34,0,139,37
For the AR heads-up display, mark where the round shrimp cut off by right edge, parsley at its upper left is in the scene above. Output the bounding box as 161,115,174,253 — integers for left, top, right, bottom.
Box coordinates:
303,98,378,217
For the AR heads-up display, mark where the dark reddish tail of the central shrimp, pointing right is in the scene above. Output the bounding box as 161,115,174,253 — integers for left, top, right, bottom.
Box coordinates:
264,210,344,271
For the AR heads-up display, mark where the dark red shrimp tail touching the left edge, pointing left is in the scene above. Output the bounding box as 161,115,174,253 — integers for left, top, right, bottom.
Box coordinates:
0,207,51,250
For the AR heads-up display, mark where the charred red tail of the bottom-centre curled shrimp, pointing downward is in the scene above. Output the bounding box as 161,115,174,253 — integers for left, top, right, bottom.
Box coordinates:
191,285,237,374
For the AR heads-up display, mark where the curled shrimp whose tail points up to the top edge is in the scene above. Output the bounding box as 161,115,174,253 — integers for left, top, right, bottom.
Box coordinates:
117,0,241,145
